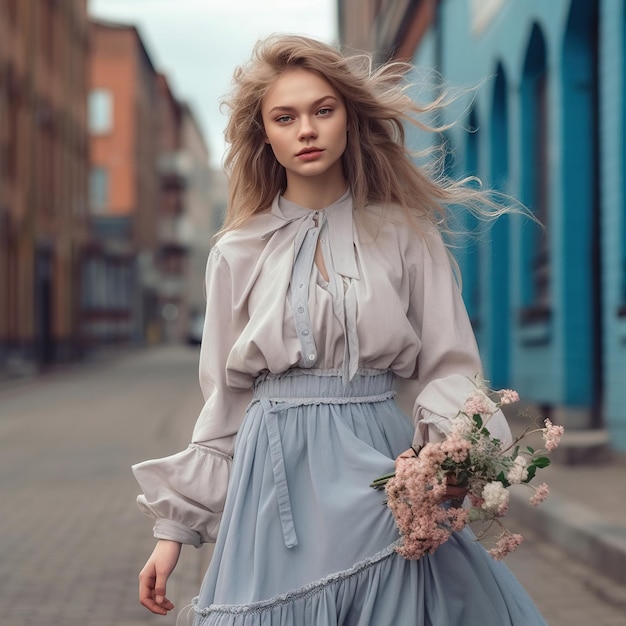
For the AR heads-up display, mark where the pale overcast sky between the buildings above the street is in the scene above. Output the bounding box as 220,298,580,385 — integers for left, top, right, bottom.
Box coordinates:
88,0,337,167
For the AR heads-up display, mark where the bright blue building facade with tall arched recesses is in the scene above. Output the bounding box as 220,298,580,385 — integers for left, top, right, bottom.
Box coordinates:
410,0,626,453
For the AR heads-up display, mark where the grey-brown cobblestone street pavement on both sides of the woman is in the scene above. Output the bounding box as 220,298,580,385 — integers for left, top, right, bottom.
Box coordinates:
0,347,626,626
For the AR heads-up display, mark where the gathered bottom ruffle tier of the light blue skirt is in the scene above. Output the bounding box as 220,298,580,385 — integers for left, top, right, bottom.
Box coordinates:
194,531,546,626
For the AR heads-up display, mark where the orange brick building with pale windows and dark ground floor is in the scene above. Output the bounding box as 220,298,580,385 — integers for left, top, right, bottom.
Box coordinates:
83,20,160,345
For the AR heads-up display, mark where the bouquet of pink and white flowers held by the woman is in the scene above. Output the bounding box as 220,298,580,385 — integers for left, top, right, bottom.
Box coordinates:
371,383,563,560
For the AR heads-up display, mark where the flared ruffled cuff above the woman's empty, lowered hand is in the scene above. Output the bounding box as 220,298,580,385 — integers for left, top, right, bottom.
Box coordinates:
132,444,232,546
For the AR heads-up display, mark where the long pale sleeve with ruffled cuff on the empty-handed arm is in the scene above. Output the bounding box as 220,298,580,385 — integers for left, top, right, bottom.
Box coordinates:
132,246,252,547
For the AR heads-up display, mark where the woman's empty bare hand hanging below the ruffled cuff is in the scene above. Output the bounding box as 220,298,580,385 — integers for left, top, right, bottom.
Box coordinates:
139,539,181,615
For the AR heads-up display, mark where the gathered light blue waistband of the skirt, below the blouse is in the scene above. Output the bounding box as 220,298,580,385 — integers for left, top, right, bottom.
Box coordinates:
253,368,394,403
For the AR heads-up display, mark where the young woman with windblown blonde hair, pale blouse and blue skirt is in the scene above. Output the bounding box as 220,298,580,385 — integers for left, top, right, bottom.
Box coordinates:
134,36,545,626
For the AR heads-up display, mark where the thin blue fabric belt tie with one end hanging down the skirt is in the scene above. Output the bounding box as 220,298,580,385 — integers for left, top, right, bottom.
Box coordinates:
258,390,396,548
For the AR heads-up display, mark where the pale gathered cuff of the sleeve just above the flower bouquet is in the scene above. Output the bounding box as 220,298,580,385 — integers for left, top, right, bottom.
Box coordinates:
413,374,513,448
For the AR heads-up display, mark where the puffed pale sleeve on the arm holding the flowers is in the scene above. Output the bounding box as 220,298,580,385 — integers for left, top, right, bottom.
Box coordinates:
399,228,511,446
